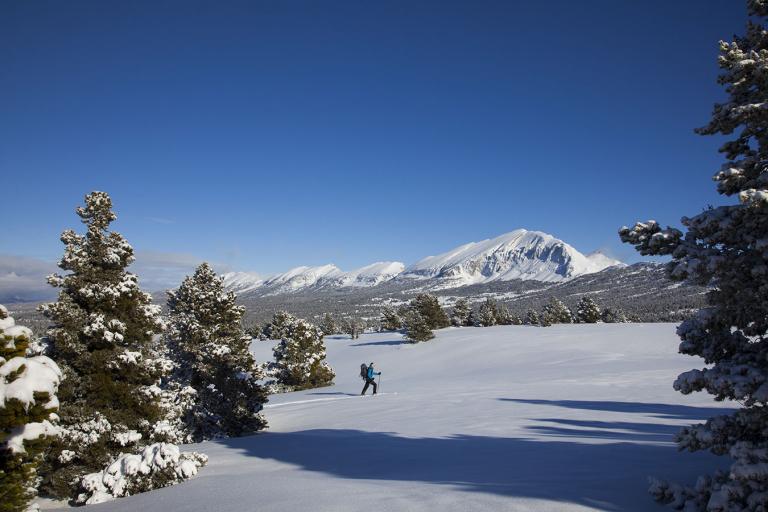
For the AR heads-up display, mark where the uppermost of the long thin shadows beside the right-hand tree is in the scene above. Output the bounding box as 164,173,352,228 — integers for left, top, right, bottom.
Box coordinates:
499,398,734,420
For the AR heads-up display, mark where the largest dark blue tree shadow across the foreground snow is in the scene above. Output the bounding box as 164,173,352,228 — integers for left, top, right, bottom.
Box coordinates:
220,426,724,511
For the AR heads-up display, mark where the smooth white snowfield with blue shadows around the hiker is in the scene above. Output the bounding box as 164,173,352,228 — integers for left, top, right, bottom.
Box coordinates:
48,324,727,512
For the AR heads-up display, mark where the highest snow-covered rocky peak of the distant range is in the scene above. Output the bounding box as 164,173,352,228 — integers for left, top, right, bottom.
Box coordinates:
400,229,623,287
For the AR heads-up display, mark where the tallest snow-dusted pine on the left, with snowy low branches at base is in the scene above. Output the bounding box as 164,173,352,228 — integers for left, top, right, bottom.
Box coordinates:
40,192,204,503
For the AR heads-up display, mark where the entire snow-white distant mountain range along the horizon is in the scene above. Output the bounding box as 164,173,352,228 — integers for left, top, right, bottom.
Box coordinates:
224,229,624,296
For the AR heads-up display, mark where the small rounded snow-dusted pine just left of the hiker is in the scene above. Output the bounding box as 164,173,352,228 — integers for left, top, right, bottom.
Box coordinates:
270,320,336,390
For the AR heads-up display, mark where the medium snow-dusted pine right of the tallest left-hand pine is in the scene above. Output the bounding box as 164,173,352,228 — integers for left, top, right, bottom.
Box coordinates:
166,263,267,442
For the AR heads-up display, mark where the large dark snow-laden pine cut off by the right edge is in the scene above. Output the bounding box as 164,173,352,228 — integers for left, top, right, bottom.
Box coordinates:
619,0,768,512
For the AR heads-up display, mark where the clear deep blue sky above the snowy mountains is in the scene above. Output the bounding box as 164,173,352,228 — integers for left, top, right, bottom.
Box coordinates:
0,0,746,288
